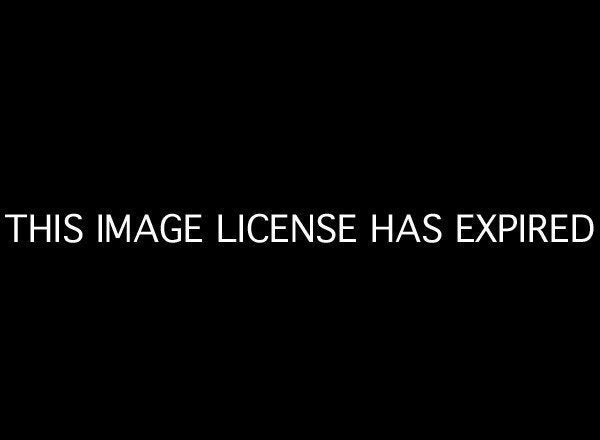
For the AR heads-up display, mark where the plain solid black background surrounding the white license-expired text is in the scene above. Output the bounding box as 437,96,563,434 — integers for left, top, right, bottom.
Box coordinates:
1,5,598,433
